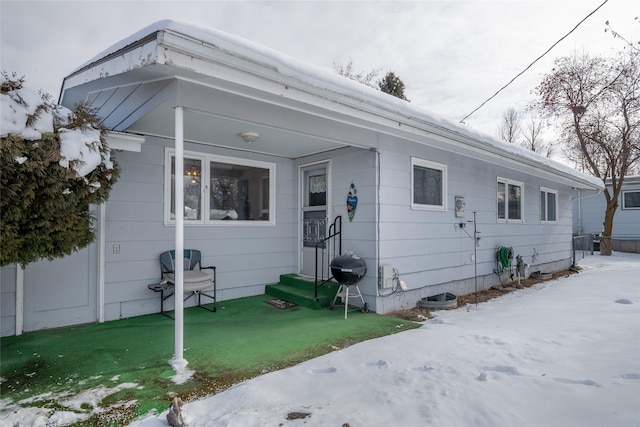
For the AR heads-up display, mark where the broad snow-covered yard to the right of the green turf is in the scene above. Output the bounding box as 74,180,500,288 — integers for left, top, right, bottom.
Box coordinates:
131,253,640,427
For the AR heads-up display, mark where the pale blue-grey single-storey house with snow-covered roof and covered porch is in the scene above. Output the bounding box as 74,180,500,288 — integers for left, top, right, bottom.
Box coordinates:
1,21,603,335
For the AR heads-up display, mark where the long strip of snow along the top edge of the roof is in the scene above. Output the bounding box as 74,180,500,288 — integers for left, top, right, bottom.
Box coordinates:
70,19,604,189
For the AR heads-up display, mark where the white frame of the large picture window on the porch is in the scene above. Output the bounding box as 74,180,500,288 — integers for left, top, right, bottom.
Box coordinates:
163,147,277,227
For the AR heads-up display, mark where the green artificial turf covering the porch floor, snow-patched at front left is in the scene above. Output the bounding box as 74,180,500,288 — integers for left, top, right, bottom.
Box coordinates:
0,296,419,425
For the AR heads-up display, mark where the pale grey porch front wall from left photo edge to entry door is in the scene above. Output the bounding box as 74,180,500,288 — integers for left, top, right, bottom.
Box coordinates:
0,138,297,336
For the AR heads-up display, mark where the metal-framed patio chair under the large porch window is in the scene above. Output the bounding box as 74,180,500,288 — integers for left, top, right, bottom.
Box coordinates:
149,249,217,317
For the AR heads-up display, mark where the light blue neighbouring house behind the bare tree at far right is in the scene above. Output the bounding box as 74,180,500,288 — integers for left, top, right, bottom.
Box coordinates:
573,176,640,253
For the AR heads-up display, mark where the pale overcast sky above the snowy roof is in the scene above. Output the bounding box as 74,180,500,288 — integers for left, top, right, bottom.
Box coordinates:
0,0,640,140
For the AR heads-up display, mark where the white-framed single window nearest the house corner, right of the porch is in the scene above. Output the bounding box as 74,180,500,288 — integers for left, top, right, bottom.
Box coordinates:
411,157,447,210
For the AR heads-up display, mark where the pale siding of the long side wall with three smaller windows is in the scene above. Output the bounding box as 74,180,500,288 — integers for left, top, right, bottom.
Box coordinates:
370,139,572,312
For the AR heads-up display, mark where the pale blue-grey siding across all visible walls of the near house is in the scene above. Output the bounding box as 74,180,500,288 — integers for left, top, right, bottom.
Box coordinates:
1,132,592,335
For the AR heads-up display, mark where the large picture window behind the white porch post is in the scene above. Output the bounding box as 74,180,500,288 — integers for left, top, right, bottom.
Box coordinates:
165,150,275,225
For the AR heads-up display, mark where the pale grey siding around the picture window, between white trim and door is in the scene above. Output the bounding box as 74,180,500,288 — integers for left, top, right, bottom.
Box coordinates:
105,138,297,320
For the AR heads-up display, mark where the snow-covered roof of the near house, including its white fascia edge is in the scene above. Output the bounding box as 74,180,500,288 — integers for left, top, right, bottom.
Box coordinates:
63,20,604,189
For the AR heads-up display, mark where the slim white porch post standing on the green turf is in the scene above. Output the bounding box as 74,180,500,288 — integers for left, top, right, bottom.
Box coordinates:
169,105,188,372
